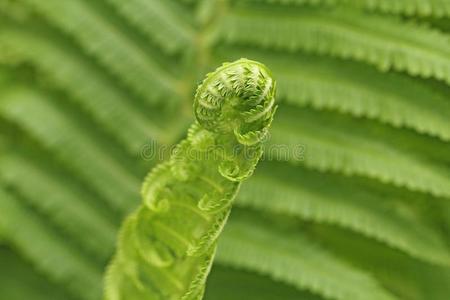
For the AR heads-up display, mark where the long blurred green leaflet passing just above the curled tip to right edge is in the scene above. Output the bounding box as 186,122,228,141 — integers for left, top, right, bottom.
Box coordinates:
221,9,450,83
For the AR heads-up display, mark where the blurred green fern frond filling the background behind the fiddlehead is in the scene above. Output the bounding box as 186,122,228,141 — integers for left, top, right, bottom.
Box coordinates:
0,0,450,300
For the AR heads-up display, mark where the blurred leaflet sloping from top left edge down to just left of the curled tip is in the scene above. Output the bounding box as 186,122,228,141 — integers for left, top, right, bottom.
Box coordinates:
20,0,177,104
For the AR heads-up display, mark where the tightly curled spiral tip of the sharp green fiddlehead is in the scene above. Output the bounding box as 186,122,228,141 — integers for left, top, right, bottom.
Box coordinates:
194,58,276,145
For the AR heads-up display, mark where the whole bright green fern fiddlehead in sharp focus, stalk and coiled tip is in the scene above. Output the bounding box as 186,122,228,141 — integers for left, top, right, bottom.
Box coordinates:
105,59,276,300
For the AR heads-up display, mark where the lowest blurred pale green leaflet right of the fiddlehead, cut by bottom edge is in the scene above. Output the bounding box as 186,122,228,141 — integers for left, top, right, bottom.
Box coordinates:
217,213,397,300
